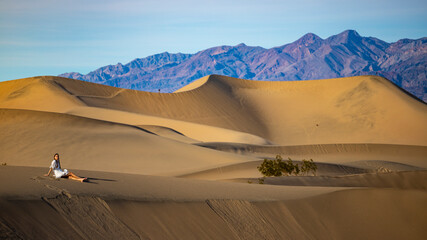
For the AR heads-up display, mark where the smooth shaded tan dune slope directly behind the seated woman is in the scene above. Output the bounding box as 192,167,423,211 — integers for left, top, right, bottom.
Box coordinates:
0,109,258,176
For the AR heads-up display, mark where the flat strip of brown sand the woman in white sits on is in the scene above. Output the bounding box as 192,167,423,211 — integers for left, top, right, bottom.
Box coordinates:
0,166,347,202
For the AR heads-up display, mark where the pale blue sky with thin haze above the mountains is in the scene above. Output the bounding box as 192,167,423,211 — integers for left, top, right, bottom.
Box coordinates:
0,0,427,81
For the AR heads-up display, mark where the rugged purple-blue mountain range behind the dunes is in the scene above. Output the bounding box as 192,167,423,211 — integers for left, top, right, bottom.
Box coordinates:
59,30,427,102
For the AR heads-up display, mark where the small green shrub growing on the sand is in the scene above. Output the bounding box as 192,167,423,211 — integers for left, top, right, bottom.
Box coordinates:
257,155,317,177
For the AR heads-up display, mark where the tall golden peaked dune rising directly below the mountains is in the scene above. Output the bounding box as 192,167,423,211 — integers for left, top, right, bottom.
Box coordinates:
0,75,427,146
